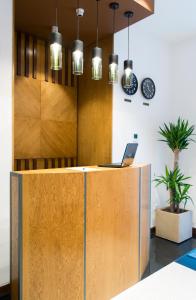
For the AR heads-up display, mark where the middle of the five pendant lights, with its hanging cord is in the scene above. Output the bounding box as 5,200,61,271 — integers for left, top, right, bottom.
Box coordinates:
92,0,102,80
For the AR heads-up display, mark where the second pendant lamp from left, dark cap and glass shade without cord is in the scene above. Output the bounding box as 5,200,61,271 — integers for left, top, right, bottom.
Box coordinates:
72,40,84,75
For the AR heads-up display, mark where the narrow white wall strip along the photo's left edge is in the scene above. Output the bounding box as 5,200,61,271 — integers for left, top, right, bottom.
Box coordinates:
0,0,13,286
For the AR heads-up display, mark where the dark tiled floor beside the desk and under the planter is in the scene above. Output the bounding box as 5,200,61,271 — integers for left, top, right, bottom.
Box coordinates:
0,237,196,300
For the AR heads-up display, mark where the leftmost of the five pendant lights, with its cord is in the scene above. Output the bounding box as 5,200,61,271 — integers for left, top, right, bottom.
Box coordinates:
50,8,62,71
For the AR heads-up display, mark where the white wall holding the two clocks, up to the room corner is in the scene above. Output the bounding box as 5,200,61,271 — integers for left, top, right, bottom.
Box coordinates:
113,21,172,226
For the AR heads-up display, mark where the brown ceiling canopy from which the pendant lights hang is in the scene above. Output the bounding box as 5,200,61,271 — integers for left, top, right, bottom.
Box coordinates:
15,0,154,46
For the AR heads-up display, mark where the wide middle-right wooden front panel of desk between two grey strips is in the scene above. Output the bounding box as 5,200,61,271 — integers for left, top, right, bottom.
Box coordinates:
86,168,139,300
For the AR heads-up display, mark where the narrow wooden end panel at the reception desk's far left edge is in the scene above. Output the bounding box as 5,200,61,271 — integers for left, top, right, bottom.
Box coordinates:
10,176,19,300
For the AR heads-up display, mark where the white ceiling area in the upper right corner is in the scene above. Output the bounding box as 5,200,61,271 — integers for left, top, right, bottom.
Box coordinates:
134,0,196,43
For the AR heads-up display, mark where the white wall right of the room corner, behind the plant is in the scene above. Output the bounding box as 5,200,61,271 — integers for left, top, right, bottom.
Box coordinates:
171,36,196,227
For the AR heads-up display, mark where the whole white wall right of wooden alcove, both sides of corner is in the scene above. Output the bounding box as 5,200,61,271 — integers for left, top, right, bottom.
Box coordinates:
113,22,196,227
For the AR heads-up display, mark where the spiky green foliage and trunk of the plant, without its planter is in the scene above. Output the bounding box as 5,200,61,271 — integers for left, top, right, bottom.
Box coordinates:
155,118,195,213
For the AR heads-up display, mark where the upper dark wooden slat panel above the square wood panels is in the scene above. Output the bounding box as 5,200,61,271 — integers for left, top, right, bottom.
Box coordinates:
15,32,72,86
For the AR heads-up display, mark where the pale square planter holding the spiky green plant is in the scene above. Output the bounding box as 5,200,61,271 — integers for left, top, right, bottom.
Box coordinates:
156,209,192,243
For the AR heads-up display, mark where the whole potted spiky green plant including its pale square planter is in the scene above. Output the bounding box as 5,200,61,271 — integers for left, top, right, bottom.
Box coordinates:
155,118,195,243
